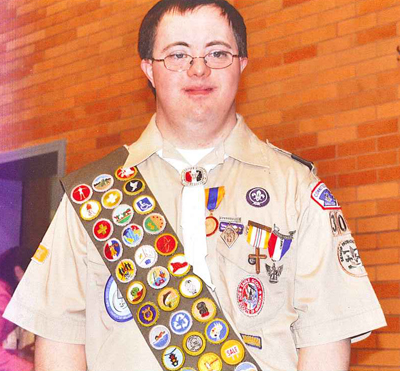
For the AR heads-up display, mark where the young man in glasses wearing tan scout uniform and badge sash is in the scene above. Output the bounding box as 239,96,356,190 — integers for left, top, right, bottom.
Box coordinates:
6,0,385,371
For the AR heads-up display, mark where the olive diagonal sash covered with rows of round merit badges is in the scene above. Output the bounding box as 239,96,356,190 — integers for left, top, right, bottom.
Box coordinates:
62,147,261,371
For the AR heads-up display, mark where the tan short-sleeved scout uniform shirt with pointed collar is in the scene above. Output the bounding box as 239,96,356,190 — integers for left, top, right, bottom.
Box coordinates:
6,116,385,371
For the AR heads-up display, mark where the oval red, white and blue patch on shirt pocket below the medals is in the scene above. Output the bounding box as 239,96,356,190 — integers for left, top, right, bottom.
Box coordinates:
236,277,264,317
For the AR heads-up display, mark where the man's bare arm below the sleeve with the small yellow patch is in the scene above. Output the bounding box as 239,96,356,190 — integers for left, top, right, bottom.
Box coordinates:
35,336,86,371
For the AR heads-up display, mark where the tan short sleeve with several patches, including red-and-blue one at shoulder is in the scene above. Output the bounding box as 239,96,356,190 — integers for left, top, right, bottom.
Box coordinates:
292,181,386,348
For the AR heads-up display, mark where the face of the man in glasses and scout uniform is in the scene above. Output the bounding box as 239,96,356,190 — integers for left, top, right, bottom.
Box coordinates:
142,6,247,126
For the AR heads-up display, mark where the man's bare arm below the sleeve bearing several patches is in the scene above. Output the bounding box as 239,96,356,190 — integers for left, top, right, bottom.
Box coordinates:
297,339,351,371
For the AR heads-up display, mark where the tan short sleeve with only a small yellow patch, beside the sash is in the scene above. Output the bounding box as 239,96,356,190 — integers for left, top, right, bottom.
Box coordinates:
4,195,88,344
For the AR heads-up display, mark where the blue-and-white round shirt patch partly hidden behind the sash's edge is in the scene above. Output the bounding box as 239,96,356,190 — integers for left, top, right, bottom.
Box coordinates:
104,276,133,322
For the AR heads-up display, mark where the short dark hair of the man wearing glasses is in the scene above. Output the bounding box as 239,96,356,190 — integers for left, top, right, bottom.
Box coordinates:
138,0,247,59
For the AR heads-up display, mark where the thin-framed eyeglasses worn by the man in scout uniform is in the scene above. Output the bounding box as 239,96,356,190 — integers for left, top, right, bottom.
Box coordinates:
152,50,239,72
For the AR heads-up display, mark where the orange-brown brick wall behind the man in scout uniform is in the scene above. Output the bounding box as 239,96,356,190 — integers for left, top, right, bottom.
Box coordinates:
0,0,400,371
